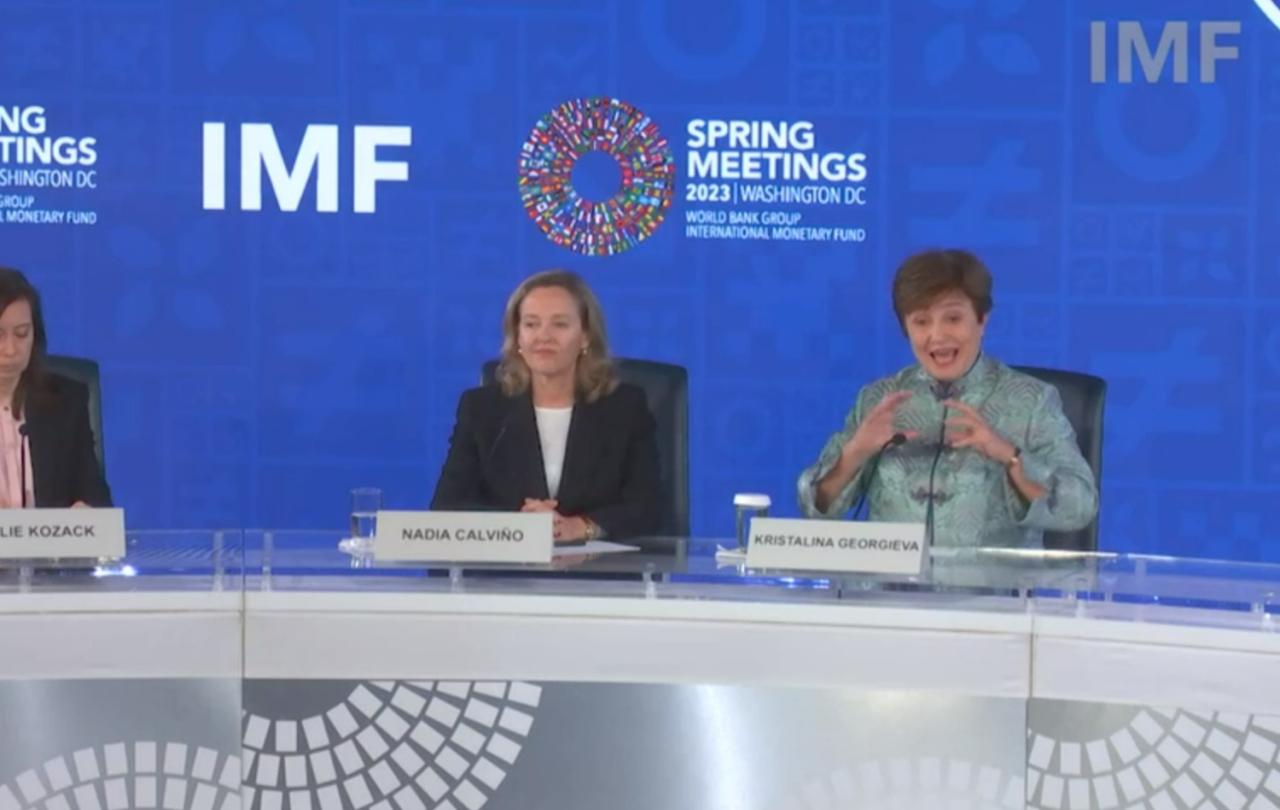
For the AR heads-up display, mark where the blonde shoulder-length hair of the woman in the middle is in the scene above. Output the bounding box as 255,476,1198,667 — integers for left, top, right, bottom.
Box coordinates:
495,270,618,402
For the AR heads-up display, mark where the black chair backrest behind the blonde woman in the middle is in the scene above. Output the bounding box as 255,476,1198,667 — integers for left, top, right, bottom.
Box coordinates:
480,357,689,537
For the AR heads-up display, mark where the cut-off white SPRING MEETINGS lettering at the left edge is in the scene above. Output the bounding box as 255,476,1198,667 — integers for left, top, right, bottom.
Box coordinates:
0,104,97,226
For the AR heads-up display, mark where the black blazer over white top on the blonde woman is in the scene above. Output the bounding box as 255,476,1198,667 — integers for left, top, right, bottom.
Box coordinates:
431,384,662,539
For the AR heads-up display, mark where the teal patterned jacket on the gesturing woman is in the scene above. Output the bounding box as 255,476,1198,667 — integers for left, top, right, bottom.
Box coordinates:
799,354,1098,548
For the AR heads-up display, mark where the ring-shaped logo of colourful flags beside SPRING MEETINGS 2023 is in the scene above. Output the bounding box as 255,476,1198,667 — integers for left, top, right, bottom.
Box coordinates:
520,97,676,256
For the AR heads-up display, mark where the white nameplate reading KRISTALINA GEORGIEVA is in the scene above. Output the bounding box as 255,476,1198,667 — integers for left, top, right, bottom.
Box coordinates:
746,517,924,576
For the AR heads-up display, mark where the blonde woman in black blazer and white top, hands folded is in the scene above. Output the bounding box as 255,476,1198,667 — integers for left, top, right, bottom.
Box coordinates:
431,270,660,543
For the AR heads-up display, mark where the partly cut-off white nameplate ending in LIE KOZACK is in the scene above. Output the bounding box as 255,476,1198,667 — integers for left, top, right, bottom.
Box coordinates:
0,509,124,559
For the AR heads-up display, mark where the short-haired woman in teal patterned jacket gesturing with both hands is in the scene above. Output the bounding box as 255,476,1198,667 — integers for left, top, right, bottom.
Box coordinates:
799,251,1098,548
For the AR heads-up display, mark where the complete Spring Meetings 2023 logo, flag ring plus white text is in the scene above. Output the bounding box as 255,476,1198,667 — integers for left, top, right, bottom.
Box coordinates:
518,97,873,256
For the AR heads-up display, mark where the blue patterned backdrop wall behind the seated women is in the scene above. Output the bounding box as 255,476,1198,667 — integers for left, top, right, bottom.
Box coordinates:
0,0,1280,559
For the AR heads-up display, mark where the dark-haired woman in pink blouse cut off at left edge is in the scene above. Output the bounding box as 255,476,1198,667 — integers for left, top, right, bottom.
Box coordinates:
0,267,111,509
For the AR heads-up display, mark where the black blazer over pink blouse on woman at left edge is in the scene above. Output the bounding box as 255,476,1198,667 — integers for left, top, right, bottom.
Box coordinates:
23,374,111,507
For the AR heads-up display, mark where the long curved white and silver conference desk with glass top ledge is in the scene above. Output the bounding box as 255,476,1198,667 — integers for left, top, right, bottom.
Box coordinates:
0,532,1280,810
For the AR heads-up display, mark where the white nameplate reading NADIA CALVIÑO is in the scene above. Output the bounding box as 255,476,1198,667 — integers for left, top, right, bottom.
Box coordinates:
374,511,553,564
